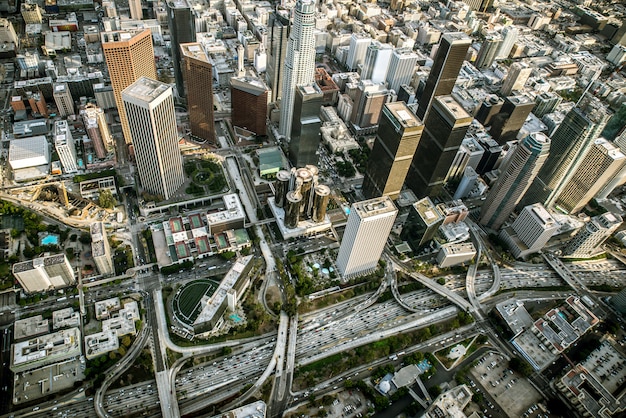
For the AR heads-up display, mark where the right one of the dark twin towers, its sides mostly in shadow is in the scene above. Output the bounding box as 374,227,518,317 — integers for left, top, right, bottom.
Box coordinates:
406,96,472,197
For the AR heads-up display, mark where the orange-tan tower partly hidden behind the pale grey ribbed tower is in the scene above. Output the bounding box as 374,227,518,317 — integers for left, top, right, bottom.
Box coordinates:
101,29,157,144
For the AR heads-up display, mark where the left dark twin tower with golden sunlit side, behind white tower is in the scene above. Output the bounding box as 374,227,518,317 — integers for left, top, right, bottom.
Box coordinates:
363,102,424,199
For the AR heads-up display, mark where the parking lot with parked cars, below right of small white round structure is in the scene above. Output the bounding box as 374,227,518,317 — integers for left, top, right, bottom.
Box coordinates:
470,353,542,418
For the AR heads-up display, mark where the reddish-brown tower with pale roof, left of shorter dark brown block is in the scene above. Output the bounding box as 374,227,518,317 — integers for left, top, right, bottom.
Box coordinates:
180,42,215,143
